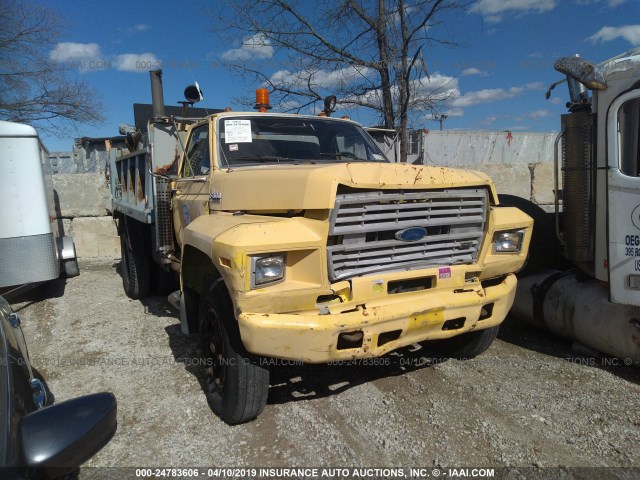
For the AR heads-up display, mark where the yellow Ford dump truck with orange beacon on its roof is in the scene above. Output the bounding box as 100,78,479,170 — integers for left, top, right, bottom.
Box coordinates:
110,71,532,424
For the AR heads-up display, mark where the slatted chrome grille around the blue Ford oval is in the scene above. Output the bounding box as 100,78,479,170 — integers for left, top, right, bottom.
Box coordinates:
327,189,487,281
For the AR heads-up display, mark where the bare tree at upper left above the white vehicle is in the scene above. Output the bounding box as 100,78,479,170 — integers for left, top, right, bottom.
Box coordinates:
0,0,103,135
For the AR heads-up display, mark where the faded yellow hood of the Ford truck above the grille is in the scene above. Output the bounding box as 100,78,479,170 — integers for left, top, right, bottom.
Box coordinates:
211,162,497,211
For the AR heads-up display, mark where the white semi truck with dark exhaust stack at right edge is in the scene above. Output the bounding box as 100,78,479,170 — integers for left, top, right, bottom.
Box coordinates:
508,49,640,364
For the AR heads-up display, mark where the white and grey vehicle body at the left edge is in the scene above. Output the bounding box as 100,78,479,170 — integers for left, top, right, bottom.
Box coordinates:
0,121,79,287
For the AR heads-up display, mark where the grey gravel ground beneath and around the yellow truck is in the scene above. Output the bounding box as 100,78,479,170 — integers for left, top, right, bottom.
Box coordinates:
8,261,640,478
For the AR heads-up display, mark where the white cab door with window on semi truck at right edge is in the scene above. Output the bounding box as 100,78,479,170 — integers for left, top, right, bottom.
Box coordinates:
607,89,640,305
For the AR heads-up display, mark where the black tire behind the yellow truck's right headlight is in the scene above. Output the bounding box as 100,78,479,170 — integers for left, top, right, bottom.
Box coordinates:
499,195,562,277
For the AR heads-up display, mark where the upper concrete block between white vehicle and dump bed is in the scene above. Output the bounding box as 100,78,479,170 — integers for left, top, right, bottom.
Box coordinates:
53,173,107,218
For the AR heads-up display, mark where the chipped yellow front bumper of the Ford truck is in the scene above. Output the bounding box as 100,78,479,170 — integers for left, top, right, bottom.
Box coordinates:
238,274,517,363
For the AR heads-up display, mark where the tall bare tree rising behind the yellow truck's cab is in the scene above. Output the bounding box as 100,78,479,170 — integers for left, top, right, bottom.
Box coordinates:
219,0,471,161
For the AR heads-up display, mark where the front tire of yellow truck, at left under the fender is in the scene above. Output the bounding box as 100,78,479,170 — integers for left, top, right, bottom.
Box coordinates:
199,279,269,425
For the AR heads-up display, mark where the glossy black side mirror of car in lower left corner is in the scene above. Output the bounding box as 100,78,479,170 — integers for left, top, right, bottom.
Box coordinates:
19,392,118,478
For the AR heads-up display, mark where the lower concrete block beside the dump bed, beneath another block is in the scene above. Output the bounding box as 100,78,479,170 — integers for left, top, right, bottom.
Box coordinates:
68,217,120,259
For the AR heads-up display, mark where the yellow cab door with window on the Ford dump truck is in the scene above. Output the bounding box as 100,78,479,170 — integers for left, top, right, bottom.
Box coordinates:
172,121,211,248
